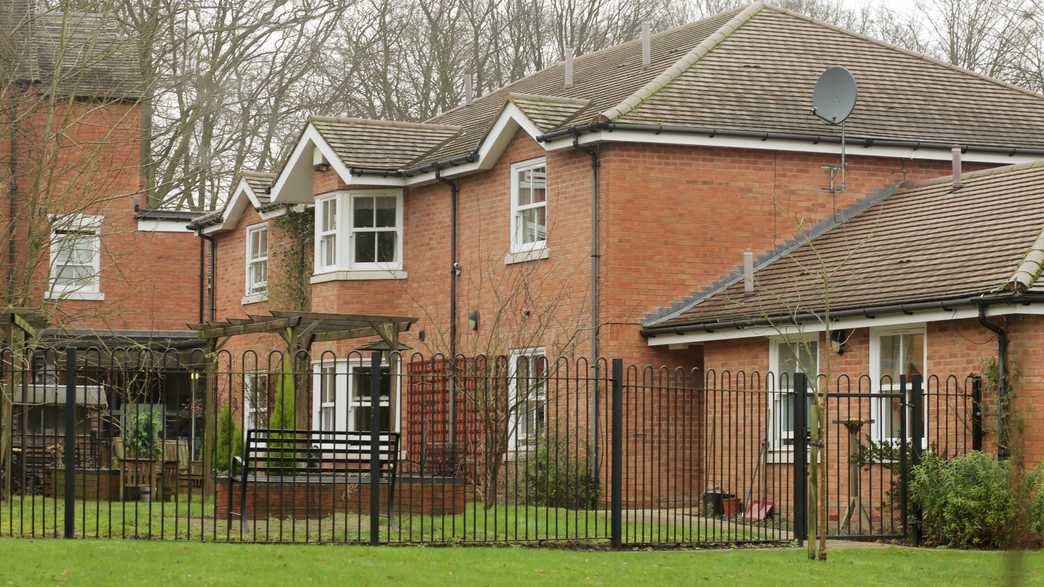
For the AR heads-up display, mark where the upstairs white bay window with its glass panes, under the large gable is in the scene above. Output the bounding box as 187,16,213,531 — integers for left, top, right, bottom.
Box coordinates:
315,190,403,273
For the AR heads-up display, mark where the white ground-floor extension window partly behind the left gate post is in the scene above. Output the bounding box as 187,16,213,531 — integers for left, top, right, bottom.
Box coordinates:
769,336,820,449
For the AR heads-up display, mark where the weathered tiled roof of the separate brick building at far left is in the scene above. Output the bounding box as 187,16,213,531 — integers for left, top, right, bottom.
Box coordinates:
0,0,145,99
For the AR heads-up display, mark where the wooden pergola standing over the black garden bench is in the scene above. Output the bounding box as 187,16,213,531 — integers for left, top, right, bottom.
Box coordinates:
189,310,417,491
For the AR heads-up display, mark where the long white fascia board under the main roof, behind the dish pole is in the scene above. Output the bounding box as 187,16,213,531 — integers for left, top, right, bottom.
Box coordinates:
544,131,1041,165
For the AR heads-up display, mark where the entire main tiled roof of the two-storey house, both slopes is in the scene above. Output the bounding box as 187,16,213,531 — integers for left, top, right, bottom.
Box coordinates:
413,4,1044,167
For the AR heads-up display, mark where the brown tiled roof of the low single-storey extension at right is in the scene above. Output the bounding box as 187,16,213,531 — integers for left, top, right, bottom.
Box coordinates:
644,162,1044,330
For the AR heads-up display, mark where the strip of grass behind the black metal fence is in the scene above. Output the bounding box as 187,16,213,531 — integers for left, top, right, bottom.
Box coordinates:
0,496,785,544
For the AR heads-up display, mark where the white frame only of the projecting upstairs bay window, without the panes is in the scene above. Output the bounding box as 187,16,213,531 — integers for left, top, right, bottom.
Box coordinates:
315,189,405,277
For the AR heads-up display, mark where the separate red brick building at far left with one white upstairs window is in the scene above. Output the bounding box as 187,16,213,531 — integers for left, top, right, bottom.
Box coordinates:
0,0,204,447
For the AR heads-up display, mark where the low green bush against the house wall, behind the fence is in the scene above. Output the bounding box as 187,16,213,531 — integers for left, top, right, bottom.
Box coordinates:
525,443,598,510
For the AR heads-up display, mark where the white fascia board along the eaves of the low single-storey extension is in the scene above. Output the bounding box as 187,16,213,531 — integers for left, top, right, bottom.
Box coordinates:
647,304,1044,347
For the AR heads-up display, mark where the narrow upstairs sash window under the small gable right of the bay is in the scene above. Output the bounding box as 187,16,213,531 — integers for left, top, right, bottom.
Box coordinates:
511,159,547,253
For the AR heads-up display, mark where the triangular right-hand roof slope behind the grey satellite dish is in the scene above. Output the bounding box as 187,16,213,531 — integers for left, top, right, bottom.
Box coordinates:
607,7,1044,148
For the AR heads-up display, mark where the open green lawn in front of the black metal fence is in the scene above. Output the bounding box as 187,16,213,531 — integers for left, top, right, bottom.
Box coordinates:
0,539,1044,587
